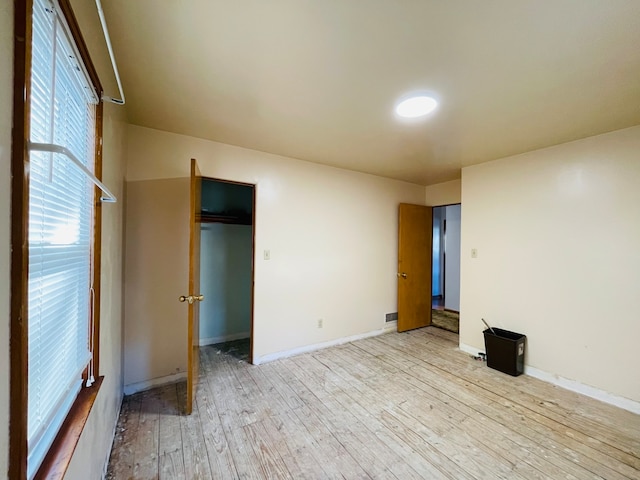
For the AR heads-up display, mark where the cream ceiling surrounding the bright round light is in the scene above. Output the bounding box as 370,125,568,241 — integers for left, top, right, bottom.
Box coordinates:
103,0,640,185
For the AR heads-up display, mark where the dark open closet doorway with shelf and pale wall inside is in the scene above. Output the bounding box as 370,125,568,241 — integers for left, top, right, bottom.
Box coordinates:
200,178,255,363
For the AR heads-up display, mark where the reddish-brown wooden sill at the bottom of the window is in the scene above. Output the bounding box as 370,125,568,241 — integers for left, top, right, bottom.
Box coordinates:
34,377,104,480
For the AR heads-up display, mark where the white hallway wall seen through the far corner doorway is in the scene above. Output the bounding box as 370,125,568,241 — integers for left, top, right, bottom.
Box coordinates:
444,205,461,312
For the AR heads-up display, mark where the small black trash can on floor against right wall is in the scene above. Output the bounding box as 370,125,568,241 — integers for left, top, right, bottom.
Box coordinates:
483,328,527,377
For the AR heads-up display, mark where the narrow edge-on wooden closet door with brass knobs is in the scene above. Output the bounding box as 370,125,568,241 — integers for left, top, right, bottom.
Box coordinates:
185,158,204,415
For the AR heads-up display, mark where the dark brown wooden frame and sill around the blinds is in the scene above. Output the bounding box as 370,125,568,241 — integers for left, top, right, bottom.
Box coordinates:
9,0,103,480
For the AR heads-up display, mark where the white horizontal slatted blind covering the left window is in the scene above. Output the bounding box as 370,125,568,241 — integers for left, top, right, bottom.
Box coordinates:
27,0,97,478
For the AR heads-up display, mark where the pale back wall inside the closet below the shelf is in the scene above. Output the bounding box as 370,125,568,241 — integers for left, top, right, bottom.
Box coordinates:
200,223,253,344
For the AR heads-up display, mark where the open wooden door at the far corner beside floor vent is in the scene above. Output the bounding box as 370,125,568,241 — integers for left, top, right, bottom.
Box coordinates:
398,203,433,332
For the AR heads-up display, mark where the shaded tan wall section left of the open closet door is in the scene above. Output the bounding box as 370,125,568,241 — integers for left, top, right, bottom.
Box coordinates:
123,178,189,385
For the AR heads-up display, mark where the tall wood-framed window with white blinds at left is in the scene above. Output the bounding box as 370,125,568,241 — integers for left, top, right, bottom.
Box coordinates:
10,0,101,478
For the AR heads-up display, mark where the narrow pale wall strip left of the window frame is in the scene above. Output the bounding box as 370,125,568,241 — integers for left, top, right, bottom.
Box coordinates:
0,2,13,478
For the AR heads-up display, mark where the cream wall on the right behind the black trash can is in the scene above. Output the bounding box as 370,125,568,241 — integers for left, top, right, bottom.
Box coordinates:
460,126,640,402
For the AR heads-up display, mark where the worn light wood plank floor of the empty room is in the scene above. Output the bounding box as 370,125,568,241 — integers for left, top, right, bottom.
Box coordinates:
107,327,640,480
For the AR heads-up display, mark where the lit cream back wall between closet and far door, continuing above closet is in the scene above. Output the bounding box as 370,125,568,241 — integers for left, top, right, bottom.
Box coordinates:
125,126,424,371
